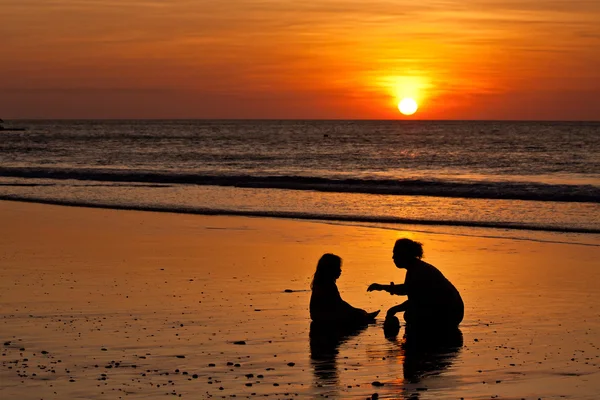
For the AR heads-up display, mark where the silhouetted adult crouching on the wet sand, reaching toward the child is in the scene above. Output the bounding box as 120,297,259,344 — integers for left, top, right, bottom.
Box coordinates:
367,239,464,330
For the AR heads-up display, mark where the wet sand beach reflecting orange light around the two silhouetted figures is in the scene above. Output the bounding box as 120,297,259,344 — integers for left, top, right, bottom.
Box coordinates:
0,201,600,399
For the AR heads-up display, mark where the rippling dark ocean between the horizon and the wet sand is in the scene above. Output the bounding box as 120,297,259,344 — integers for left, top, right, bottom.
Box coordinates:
0,120,600,237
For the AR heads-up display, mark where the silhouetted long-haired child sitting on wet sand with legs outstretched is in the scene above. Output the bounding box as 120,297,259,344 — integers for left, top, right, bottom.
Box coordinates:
310,254,379,325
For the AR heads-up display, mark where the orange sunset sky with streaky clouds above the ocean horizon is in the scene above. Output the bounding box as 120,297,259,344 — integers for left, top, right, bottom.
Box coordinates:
0,0,600,120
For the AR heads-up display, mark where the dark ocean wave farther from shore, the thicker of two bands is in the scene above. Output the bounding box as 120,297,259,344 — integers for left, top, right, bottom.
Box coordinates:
0,167,600,203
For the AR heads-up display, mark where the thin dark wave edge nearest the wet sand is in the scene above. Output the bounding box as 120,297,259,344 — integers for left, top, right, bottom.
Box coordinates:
0,195,600,234
